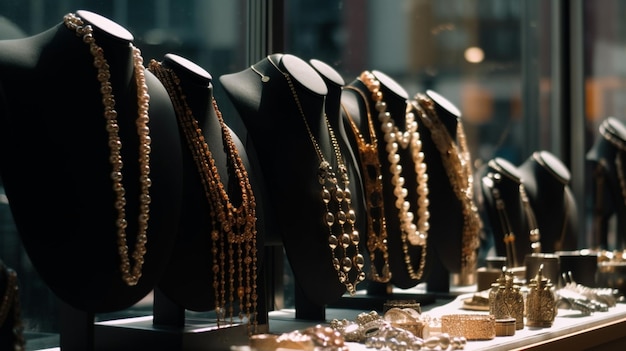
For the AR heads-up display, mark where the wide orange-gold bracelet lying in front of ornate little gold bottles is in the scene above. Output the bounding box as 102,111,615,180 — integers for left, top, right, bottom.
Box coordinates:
441,314,496,340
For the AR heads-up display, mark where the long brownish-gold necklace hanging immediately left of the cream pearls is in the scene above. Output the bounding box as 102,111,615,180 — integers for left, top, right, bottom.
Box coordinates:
341,86,392,283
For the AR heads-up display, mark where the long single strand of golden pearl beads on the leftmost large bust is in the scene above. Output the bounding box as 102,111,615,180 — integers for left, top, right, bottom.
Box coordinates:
63,13,152,286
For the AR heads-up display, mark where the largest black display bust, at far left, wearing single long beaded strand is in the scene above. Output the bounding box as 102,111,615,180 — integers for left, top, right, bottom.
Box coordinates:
0,11,182,312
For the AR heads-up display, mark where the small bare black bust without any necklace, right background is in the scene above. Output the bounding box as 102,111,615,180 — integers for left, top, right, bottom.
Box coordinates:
518,150,579,253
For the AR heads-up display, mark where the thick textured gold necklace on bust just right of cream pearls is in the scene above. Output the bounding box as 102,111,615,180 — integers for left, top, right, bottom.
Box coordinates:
415,94,482,276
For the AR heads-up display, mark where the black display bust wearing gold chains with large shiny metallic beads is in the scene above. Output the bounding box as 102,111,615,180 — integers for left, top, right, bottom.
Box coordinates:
220,54,363,306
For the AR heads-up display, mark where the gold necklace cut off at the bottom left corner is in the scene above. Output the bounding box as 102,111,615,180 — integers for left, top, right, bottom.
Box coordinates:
0,261,25,350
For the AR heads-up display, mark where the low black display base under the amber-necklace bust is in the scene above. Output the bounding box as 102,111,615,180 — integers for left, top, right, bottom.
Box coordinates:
94,316,248,351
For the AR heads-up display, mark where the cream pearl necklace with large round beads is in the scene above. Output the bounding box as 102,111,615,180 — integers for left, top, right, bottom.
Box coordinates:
359,71,430,280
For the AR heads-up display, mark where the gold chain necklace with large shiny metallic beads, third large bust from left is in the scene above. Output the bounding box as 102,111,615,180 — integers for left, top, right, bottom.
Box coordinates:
264,56,366,295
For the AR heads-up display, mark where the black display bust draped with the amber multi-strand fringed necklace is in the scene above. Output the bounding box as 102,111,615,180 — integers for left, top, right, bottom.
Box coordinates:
154,54,264,311
